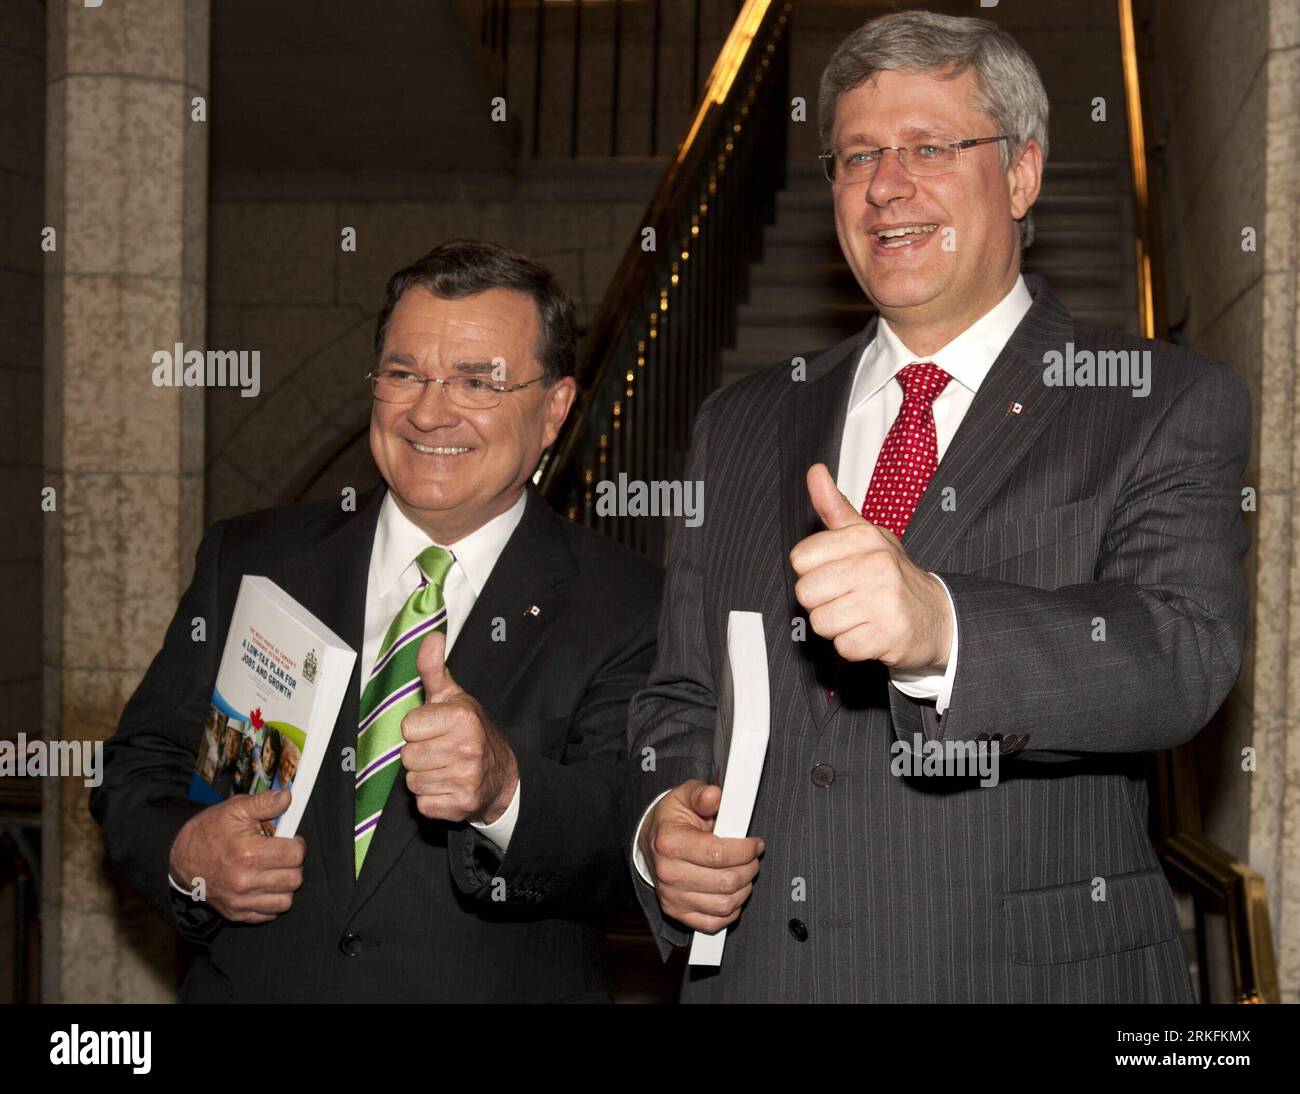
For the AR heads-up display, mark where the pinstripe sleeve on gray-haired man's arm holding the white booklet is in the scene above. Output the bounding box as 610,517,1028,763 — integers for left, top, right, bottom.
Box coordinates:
623,396,718,960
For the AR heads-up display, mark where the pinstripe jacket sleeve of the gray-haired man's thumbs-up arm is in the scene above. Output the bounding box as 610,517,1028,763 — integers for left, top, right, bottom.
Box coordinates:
889,364,1251,760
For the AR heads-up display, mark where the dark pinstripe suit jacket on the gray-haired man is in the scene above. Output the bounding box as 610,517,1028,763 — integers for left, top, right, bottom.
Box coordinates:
629,275,1251,1003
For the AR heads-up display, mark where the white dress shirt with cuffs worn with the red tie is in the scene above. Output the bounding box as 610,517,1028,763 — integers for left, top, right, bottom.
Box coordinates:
632,277,1034,885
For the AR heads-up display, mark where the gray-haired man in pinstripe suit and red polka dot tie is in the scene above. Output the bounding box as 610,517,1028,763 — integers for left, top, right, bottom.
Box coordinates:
628,12,1251,1003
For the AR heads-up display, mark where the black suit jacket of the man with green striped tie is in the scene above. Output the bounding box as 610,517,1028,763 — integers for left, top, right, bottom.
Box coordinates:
90,486,662,1002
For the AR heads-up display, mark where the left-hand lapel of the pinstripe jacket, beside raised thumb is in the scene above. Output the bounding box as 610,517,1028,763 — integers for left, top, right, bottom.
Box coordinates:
781,328,876,728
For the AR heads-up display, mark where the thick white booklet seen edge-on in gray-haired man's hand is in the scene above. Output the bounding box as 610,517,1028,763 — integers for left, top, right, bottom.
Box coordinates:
688,612,772,965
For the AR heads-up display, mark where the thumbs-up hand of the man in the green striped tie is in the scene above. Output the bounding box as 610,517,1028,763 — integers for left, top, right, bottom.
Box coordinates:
402,630,519,824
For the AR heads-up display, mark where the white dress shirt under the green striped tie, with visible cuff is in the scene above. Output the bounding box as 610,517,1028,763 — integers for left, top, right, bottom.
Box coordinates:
361,480,528,851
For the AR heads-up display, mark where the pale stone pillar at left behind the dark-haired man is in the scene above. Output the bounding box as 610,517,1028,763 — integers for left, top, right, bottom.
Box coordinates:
42,0,209,1002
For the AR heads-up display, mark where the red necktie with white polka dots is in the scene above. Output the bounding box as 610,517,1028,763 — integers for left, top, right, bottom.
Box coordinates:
862,361,952,537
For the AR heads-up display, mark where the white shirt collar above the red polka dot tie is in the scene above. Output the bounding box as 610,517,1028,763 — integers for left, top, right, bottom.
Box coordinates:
849,275,1034,413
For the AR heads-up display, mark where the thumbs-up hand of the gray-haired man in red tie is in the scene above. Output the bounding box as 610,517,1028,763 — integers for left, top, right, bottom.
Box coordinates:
790,464,953,672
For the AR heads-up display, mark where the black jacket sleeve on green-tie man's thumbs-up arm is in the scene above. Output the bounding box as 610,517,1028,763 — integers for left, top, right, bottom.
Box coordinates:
447,572,660,912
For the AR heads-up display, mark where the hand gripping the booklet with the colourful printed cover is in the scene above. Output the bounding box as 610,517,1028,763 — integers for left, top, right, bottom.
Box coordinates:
168,790,307,922
